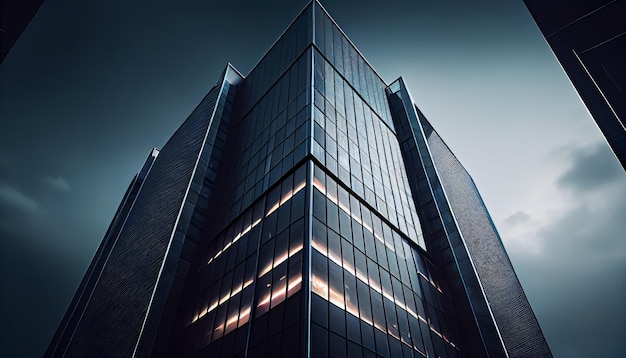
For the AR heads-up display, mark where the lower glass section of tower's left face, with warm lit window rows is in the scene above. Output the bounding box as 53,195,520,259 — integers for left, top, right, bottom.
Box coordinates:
177,165,306,356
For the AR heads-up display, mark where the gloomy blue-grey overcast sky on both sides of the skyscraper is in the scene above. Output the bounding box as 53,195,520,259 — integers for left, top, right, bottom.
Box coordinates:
0,0,626,357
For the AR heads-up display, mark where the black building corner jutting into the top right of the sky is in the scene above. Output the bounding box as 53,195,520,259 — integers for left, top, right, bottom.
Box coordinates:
524,0,626,168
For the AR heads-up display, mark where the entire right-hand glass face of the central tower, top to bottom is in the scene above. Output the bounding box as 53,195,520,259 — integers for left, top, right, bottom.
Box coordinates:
310,6,462,357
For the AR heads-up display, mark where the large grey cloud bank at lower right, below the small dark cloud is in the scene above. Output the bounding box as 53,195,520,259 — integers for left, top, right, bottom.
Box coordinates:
522,181,626,357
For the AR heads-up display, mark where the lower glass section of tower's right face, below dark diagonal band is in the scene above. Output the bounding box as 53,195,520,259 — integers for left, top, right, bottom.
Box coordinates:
311,166,458,357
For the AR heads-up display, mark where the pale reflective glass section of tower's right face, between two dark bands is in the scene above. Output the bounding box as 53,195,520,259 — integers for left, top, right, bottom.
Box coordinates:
313,52,423,245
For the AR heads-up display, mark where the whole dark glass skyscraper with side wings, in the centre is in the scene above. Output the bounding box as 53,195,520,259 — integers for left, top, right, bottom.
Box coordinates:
46,1,551,357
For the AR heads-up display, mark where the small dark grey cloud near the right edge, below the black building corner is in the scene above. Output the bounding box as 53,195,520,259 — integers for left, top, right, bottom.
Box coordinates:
558,142,624,192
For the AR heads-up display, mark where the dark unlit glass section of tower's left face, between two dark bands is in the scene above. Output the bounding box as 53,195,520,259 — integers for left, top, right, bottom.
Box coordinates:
228,48,311,218
